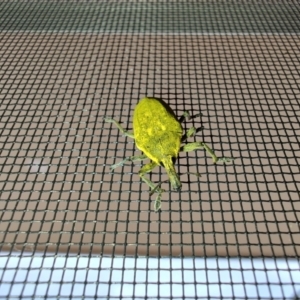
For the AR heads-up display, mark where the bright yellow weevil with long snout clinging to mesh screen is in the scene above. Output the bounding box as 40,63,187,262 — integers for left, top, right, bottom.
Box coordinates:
104,97,234,212
